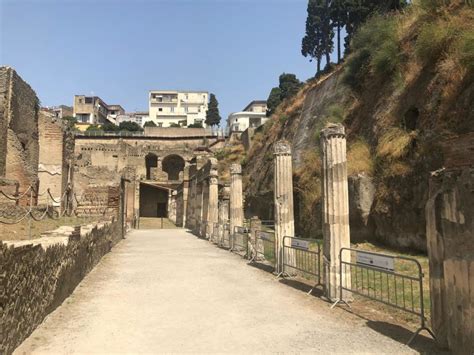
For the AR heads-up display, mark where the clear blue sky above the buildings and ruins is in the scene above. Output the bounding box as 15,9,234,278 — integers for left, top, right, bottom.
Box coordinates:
0,0,334,126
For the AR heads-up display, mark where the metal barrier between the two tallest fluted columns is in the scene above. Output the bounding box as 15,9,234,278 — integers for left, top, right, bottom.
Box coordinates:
280,237,322,294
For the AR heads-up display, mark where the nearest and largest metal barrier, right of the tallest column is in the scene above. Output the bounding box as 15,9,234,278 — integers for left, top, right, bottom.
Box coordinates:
331,248,436,345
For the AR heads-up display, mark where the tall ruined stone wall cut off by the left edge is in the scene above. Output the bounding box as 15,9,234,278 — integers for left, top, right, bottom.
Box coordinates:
0,67,39,191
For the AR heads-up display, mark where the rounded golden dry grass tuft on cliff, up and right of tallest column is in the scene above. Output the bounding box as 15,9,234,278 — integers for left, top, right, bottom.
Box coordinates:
377,127,415,160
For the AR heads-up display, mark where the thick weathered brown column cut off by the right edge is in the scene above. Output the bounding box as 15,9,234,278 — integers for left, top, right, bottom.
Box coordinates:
426,168,474,354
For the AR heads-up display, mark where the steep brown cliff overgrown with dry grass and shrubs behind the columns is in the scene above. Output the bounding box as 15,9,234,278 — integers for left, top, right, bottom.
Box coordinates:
244,0,474,250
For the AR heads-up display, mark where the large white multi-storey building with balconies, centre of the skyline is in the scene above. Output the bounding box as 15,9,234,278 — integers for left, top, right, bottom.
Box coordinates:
148,90,209,127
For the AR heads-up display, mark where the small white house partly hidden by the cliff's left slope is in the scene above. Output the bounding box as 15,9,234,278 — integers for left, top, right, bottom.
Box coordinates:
227,100,267,132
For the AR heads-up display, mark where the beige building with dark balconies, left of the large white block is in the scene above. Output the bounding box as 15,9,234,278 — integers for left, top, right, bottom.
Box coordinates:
73,95,125,130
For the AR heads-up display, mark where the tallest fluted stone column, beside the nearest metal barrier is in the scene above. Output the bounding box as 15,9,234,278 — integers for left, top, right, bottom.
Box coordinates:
321,124,351,301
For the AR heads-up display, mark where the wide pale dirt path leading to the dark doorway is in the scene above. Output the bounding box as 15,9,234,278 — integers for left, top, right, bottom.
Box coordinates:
16,229,413,354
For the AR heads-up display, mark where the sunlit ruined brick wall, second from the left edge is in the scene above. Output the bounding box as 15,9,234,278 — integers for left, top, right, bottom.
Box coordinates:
38,111,74,203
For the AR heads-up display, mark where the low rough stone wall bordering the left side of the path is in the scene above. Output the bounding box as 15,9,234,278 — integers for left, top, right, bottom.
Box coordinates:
0,222,121,354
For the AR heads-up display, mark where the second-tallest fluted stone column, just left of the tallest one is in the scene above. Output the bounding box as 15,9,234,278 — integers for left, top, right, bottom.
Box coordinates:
273,141,295,273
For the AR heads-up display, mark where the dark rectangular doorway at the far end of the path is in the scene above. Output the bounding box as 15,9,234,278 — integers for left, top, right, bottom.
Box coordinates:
140,184,168,217
